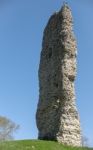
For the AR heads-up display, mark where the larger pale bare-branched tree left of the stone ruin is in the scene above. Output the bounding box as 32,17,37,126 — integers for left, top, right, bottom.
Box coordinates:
0,116,19,141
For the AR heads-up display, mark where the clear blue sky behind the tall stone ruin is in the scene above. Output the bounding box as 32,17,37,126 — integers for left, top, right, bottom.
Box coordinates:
0,0,93,146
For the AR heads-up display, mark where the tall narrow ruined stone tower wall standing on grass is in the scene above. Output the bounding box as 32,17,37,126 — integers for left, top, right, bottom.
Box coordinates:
36,4,81,146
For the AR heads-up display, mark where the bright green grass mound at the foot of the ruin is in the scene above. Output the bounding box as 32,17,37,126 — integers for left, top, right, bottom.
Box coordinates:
0,140,93,150
